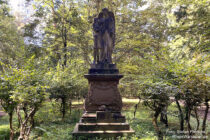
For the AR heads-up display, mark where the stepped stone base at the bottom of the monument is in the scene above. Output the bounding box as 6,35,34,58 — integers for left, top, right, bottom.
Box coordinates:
72,111,134,139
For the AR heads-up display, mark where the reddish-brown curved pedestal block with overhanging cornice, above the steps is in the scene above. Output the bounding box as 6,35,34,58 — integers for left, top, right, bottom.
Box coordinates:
85,74,123,112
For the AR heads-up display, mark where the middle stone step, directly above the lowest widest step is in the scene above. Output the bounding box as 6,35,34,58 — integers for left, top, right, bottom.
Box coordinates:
78,123,130,131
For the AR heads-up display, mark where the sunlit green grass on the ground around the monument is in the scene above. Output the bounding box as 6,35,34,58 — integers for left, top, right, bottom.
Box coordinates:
0,99,210,140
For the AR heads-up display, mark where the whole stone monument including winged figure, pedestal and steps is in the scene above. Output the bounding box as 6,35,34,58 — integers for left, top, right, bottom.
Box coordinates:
73,8,134,137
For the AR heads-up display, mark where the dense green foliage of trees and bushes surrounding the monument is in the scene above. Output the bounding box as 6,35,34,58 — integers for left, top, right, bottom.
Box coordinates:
0,0,210,139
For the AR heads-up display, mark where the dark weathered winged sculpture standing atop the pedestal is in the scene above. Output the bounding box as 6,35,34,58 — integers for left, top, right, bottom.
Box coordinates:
93,8,115,63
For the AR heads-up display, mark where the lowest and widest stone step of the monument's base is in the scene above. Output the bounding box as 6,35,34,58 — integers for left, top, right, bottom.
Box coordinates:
72,124,135,139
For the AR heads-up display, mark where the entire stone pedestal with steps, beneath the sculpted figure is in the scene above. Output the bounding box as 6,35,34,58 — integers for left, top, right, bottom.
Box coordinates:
73,64,134,139
